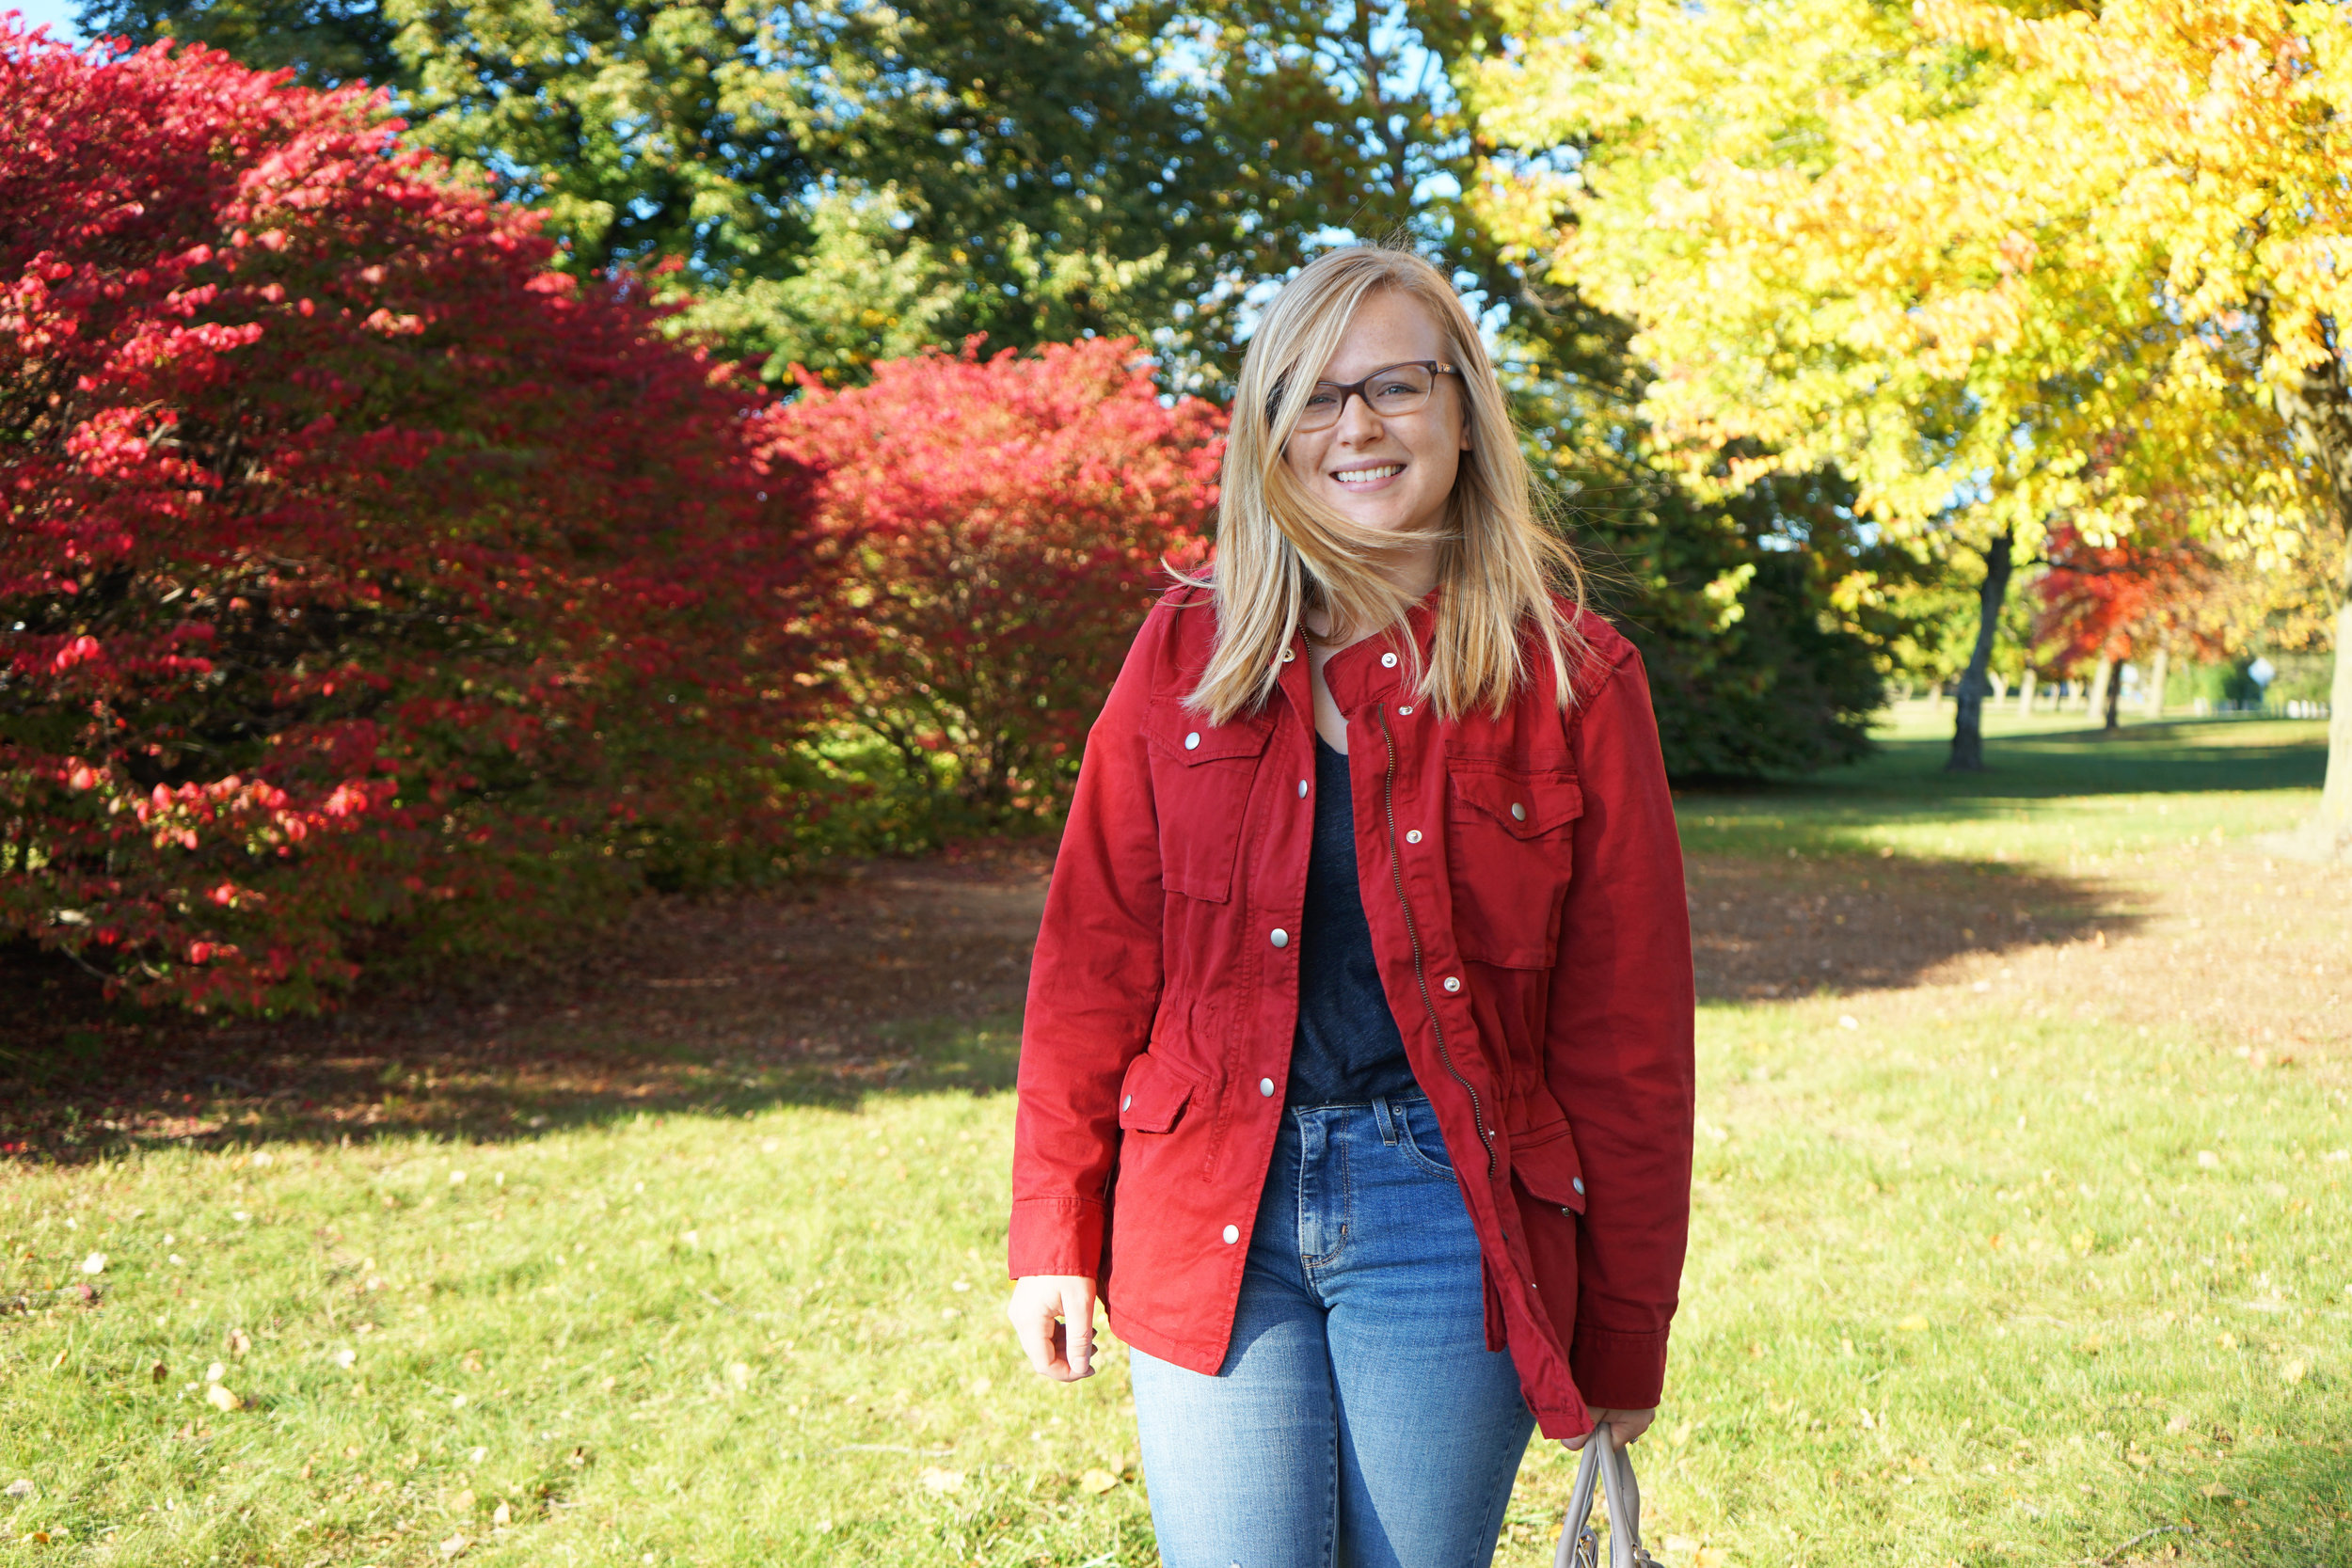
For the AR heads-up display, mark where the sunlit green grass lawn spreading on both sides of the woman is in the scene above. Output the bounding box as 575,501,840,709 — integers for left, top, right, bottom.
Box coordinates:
0,717,2352,1568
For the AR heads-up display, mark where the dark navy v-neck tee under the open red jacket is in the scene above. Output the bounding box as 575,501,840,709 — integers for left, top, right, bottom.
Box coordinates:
1284,736,1419,1105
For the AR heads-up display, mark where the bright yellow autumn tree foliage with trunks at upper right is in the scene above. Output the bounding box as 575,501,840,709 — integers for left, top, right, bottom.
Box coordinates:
1477,0,2352,847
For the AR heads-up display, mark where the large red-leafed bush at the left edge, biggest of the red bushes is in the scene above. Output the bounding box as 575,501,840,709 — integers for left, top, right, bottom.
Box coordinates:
0,16,817,1008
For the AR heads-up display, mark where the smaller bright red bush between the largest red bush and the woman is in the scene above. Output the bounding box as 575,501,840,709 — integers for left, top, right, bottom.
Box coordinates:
767,339,1223,818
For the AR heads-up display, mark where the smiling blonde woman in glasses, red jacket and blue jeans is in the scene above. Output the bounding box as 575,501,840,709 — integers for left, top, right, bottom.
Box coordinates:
1011,246,1693,1568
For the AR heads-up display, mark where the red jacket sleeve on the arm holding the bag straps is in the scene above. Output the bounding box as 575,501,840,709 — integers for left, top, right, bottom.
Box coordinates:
1546,635,1696,1411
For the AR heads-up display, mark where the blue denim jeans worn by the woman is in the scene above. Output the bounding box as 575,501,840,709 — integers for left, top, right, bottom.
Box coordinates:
1129,1096,1536,1568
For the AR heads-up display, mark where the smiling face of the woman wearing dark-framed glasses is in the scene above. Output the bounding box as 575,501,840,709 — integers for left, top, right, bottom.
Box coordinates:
1282,289,1470,549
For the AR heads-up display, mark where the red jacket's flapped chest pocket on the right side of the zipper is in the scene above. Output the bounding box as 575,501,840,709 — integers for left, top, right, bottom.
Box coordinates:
1447,757,1585,969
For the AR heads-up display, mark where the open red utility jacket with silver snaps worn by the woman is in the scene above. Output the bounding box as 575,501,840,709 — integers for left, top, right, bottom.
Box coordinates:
1009,590,1693,1439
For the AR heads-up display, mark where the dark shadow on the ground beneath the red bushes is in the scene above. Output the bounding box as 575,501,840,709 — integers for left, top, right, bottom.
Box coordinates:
0,851,1044,1162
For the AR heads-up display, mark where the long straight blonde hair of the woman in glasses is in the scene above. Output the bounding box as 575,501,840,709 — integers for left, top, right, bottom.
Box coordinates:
1179,245,1585,724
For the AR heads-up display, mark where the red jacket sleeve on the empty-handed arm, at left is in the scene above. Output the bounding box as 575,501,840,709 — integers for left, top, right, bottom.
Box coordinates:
1007,609,1171,1279
